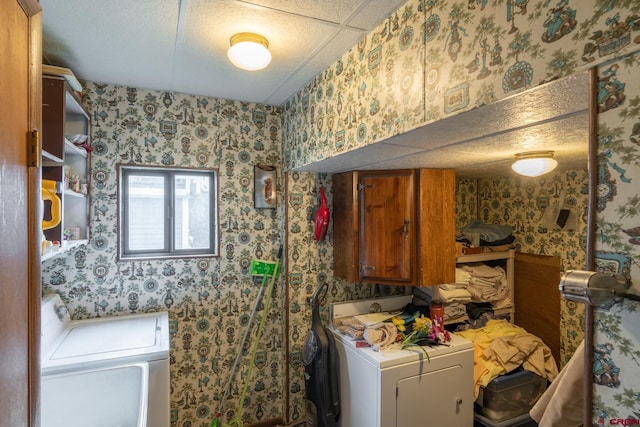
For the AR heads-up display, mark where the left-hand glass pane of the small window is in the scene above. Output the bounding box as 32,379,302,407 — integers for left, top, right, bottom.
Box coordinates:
127,174,165,251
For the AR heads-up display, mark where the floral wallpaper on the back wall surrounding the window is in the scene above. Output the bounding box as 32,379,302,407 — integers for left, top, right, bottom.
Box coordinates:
42,83,287,426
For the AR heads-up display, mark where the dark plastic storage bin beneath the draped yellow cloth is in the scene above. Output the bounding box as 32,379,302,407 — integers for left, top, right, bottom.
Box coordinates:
475,370,547,422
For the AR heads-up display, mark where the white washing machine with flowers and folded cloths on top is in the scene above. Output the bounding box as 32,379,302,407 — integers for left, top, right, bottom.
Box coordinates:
330,295,474,427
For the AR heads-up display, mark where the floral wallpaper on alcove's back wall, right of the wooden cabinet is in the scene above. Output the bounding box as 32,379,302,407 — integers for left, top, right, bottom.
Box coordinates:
456,170,588,367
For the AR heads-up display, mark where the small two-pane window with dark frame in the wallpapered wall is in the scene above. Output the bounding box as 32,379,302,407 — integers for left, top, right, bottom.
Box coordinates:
118,166,218,259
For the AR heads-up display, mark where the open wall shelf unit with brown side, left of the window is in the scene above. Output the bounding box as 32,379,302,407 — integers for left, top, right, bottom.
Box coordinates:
42,76,90,256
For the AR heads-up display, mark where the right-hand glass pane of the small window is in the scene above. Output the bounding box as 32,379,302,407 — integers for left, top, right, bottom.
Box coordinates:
174,174,211,250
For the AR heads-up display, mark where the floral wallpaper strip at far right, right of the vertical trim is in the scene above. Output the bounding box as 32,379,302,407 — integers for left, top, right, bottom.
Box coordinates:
593,53,640,425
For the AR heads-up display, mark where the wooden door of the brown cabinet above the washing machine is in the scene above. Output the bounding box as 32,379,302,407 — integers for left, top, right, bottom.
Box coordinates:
358,170,416,284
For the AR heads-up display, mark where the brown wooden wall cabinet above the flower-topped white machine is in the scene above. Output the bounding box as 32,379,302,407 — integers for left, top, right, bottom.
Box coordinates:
333,169,455,286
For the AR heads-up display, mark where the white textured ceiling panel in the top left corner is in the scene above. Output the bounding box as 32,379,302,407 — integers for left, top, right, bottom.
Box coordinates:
40,0,179,88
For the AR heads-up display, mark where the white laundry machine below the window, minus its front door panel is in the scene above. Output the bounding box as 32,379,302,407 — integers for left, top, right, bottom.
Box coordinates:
41,294,170,427
